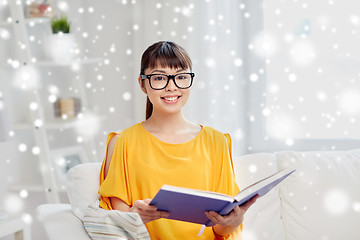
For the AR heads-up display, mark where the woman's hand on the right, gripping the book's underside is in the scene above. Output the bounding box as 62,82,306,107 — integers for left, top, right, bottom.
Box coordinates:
205,195,259,236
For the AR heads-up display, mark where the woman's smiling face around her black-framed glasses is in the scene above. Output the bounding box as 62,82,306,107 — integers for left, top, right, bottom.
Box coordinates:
139,66,190,117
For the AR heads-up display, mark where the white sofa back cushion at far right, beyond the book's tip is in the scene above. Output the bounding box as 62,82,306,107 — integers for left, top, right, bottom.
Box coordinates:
276,150,360,240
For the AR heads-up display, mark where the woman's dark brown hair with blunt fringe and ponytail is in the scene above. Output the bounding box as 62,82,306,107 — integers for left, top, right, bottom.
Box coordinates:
140,41,192,119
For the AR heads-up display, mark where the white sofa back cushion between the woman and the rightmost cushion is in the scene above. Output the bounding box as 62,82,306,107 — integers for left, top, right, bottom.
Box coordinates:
234,153,284,240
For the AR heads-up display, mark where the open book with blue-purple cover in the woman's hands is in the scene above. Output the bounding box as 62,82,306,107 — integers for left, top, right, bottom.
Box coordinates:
150,169,295,227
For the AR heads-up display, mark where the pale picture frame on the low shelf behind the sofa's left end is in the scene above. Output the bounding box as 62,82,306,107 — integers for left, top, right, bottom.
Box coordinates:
51,146,89,184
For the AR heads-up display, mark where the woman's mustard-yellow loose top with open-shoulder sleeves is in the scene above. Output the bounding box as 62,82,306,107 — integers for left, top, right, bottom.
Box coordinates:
99,123,241,240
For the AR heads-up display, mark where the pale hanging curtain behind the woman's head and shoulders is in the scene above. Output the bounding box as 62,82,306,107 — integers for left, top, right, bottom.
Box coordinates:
79,0,253,156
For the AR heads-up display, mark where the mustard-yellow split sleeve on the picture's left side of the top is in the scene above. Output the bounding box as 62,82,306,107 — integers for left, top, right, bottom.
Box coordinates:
99,132,132,210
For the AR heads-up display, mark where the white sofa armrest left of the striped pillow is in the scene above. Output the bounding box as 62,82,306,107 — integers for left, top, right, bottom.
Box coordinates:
36,204,91,240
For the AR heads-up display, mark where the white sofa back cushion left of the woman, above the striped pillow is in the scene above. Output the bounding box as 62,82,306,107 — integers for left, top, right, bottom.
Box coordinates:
66,163,101,221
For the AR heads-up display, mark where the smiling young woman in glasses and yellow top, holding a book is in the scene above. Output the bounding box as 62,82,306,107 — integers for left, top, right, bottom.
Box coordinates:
99,41,256,240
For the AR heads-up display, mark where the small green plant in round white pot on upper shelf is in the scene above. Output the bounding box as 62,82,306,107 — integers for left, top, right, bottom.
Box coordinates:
46,16,76,62
